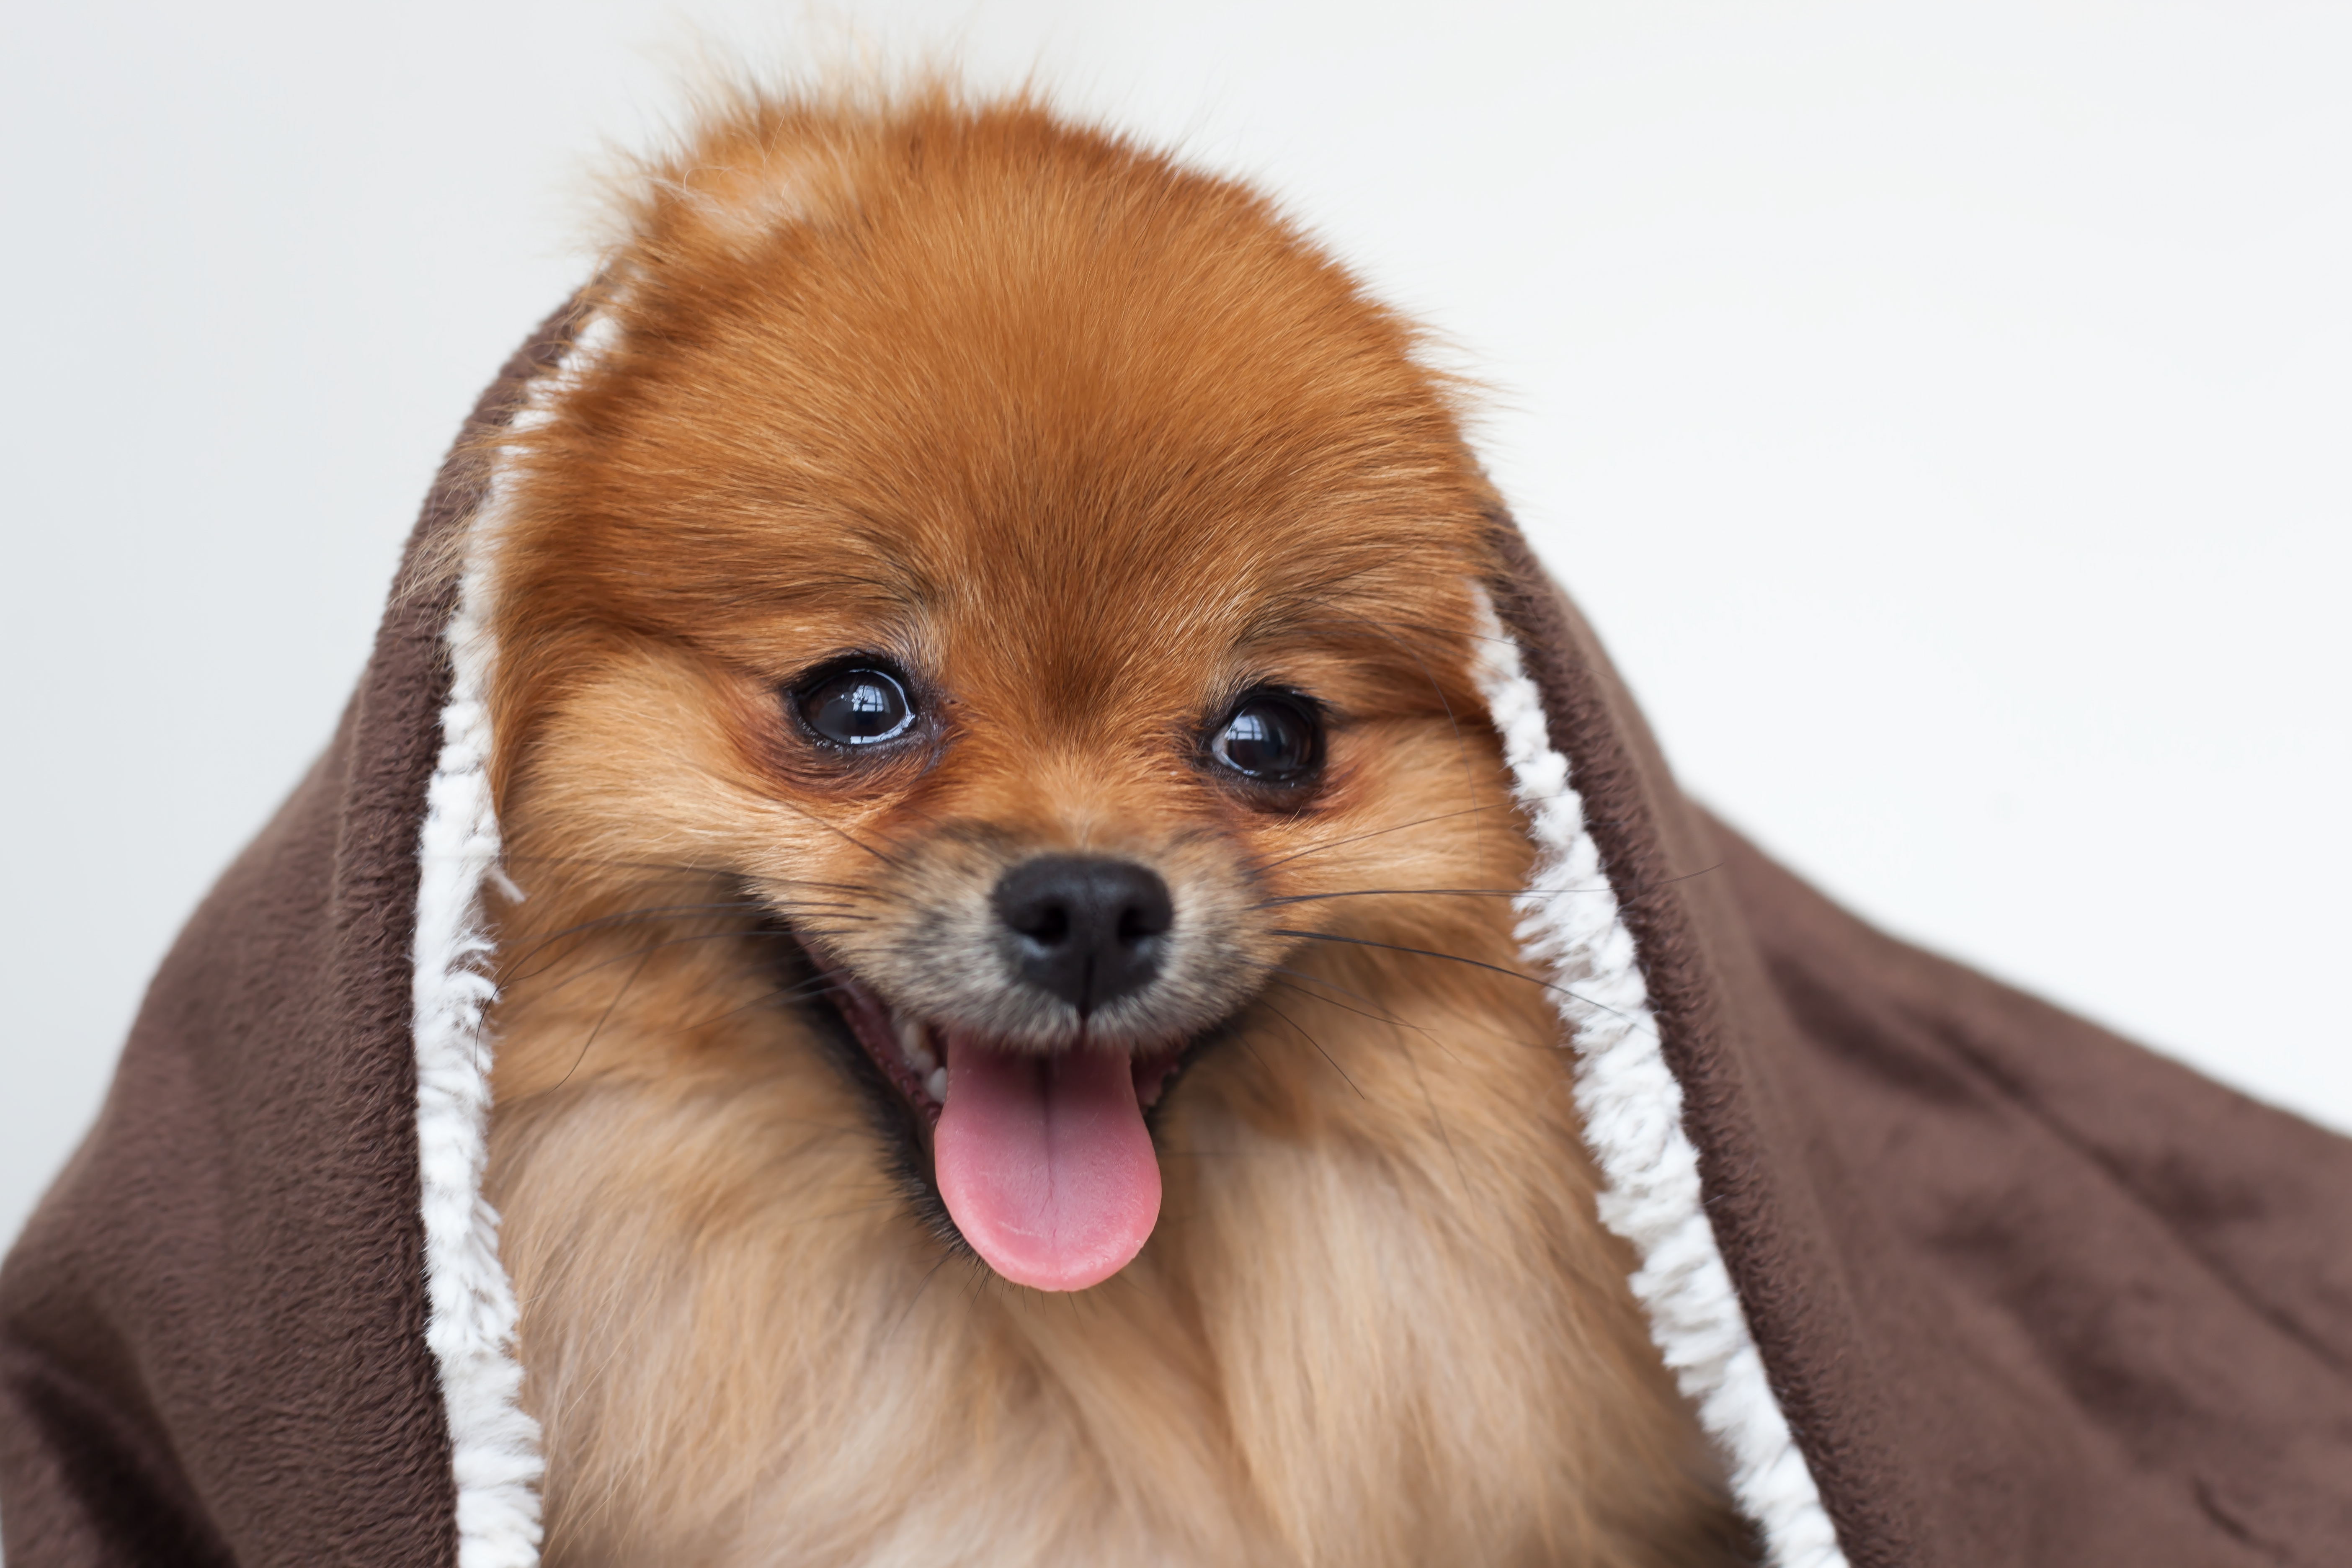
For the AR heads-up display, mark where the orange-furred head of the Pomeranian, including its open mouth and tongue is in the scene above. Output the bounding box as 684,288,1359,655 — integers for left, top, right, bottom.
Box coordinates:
494,88,1491,1288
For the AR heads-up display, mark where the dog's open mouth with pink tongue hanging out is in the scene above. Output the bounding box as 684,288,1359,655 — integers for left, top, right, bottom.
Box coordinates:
809,950,1190,1291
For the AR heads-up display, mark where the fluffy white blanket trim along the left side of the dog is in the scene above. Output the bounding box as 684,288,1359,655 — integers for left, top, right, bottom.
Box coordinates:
414,317,609,1568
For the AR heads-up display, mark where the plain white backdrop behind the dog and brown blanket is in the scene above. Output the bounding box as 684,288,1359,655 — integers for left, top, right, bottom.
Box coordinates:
0,0,2352,1237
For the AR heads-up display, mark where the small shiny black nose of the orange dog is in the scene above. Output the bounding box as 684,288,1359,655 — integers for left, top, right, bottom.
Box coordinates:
995,856,1176,1018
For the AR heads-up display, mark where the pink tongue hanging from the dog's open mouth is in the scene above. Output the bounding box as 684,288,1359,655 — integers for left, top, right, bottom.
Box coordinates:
931,1032,1160,1291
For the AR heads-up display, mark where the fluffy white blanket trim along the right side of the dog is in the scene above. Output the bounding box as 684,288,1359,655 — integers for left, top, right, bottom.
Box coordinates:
1477,592,1847,1568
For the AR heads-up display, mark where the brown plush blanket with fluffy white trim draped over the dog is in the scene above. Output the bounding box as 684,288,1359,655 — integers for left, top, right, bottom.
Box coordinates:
13,315,2352,1568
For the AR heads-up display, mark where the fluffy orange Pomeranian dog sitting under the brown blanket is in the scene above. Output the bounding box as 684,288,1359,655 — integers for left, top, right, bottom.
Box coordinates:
470,85,1750,1568
